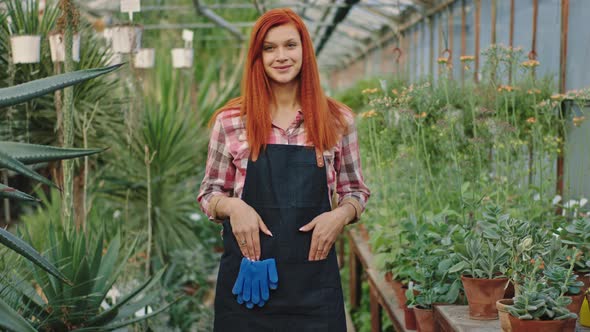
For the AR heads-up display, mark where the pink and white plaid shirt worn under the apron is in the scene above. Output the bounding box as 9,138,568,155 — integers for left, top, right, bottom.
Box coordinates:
197,109,370,220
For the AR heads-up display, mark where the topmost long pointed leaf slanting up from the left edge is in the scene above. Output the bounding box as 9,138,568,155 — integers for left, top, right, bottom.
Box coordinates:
0,64,123,108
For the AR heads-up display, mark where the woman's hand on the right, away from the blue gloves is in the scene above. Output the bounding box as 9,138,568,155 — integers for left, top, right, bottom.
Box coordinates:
299,209,347,261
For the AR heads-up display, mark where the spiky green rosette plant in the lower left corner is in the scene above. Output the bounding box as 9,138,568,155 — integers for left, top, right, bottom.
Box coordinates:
4,225,167,331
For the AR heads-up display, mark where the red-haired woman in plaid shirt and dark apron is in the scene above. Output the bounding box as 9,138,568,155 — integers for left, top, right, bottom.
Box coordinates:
198,9,370,332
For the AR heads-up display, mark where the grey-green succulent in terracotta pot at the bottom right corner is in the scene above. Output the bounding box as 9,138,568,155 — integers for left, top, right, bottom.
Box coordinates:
506,257,577,332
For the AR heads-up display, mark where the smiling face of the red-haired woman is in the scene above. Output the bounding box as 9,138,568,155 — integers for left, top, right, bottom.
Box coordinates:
262,24,303,84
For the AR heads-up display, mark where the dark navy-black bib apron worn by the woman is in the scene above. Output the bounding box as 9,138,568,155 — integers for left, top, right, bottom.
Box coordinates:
214,144,346,332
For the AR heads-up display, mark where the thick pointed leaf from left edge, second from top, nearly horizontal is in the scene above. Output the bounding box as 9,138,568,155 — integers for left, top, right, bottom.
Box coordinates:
0,142,105,165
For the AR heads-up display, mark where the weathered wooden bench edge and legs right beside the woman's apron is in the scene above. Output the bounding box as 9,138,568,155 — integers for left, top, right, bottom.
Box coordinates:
347,229,412,332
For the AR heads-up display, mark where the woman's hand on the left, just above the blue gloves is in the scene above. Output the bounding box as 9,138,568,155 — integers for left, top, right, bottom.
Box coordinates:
227,198,272,261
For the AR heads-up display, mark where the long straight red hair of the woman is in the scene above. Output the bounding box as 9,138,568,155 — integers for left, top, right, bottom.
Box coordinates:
211,8,350,160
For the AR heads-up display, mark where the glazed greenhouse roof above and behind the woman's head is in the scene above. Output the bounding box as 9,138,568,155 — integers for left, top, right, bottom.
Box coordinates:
82,0,441,69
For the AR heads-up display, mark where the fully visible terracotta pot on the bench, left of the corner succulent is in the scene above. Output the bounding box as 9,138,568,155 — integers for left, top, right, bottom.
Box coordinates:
461,276,508,320
